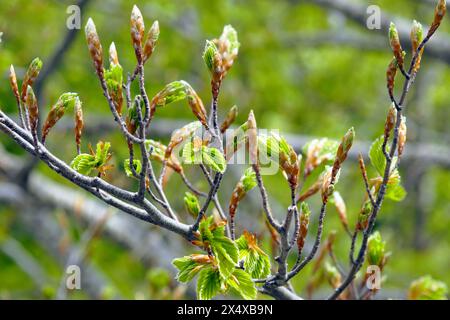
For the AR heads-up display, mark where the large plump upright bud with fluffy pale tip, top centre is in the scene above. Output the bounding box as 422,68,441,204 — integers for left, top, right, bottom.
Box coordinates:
203,25,240,97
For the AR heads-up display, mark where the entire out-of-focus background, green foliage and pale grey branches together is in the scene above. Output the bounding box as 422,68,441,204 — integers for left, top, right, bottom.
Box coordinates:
0,0,450,299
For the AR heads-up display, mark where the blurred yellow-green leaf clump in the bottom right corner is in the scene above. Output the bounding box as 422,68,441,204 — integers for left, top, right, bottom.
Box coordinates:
408,275,448,300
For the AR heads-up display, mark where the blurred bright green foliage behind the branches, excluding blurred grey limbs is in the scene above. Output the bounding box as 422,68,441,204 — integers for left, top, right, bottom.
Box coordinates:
0,0,450,298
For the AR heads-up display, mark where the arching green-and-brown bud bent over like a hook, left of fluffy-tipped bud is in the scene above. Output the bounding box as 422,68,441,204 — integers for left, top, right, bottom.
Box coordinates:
150,80,209,129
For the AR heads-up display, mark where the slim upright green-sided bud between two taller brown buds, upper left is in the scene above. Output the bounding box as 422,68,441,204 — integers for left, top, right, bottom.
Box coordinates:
105,42,123,115
